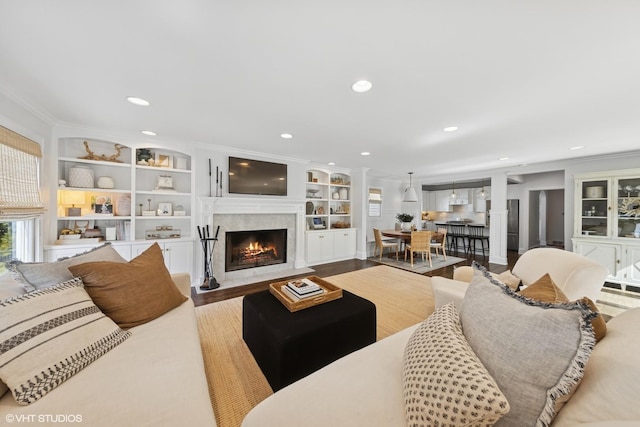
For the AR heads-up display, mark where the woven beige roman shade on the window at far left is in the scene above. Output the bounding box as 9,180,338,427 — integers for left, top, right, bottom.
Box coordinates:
0,126,44,219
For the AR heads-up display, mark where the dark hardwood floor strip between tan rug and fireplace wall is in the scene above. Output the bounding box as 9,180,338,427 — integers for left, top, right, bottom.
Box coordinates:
191,251,519,306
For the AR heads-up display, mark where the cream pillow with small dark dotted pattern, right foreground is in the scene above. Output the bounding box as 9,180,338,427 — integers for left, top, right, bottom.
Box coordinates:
402,302,509,427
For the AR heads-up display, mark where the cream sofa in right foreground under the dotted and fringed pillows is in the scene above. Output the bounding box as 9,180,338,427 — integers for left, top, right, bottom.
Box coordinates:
242,251,640,427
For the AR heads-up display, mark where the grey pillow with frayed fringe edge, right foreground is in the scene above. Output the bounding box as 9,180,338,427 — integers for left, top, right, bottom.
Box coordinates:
460,262,596,426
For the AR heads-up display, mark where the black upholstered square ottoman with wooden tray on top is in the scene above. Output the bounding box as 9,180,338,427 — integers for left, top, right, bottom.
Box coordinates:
242,290,376,391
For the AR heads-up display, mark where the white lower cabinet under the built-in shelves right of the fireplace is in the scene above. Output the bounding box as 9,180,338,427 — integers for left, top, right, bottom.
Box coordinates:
305,228,356,265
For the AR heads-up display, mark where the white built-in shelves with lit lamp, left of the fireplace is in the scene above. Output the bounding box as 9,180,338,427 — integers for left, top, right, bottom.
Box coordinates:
45,137,194,272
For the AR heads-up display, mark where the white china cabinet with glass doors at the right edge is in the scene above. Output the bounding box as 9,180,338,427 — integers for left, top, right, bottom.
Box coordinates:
572,169,640,289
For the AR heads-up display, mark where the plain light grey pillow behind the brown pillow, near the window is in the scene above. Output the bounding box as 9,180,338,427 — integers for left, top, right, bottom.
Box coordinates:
7,243,127,292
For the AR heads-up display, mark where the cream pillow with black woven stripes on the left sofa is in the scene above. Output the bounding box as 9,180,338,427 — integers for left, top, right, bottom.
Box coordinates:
0,278,131,405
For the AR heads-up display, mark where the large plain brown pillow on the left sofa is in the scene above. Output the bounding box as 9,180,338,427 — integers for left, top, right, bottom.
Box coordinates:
68,243,187,329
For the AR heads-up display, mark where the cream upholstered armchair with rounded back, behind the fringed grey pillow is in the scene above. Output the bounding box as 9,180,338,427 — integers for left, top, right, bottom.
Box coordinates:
431,248,608,308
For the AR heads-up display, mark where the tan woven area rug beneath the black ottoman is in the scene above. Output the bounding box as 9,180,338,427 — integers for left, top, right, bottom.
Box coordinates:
196,266,434,427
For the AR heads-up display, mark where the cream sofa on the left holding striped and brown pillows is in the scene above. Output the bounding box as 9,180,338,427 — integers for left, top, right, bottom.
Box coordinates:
0,274,216,427
